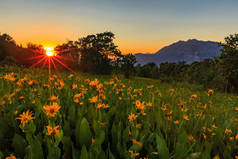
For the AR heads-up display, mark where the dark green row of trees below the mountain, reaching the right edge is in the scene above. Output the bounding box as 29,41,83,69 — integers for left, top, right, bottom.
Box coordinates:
135,34,238,93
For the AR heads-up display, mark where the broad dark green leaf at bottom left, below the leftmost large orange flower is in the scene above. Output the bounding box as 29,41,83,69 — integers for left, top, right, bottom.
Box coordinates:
12,134,27,158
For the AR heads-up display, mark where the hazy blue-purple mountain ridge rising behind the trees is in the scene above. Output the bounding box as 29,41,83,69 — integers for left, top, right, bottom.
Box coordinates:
135,39,221,65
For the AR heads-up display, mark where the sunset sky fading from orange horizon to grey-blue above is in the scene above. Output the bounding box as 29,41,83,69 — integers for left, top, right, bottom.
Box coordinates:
0,0,238,53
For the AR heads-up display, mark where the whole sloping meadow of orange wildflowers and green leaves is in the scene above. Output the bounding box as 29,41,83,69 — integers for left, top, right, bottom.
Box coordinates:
0,66,238,159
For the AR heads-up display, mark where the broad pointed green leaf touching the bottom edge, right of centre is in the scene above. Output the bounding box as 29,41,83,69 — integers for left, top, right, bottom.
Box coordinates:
155,134,169,159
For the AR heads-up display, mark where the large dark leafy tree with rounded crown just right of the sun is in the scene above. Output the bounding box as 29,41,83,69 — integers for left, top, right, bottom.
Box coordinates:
75,32,122,74
